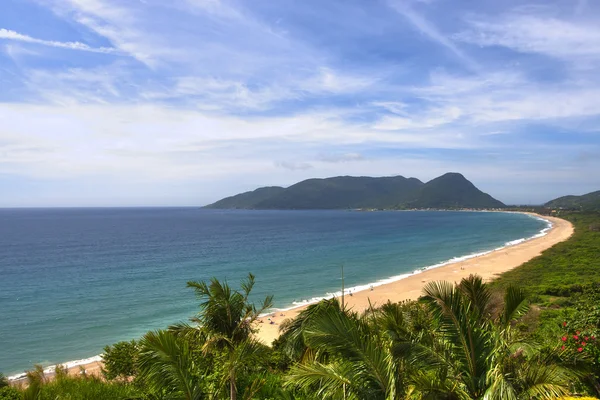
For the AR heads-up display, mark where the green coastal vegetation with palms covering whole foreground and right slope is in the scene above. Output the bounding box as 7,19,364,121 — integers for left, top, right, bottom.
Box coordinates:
0,212,600,400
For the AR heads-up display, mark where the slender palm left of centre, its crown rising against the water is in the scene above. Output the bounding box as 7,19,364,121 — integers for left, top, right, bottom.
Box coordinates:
187,274,273,400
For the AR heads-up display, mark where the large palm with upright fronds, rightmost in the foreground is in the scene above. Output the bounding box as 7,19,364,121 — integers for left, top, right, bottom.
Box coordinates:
412,275,578,399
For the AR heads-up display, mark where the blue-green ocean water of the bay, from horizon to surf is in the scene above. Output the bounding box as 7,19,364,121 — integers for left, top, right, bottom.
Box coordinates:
0,208,547,375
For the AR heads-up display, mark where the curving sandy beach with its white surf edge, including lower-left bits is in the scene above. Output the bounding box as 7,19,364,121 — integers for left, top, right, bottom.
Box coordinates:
8,211,574,385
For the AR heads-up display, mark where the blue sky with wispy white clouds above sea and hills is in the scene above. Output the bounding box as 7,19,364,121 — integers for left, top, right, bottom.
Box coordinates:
0,0,600,207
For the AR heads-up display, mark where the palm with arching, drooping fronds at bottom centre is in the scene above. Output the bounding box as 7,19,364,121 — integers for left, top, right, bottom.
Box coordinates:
287,307,404,399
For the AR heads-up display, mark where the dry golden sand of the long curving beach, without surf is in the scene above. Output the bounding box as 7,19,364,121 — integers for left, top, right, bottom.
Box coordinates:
252,214,574,345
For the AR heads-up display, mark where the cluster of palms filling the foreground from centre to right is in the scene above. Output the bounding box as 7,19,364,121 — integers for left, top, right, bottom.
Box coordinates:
287,276,579,400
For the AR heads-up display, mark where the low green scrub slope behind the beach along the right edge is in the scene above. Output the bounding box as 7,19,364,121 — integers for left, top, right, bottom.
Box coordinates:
492,212,600,394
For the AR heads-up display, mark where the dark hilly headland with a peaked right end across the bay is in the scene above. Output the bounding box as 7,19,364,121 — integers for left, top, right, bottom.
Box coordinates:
206,173,504,210
